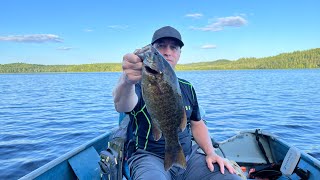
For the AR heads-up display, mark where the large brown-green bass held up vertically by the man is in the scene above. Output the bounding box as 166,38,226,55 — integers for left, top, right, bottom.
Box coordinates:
135,45,187,171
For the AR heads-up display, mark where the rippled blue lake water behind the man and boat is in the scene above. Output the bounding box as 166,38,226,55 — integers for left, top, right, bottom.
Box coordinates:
0,69,320,179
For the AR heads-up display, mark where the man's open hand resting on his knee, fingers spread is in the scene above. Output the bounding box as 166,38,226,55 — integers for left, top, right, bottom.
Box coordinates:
206,153,236,174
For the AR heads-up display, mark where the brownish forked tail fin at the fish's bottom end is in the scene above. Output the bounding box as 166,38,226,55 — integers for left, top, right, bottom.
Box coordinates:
164,144,187,171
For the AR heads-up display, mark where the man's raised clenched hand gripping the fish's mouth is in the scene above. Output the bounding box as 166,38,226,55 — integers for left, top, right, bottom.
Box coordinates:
122,53,142,84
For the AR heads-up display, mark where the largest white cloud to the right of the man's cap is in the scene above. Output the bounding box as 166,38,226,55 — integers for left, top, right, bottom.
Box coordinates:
191,16,248,31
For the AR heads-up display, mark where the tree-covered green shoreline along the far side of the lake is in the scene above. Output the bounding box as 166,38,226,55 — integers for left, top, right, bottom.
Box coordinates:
0,48,320,73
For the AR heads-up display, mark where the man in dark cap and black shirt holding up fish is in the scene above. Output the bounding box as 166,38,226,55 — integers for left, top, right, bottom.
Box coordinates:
113,26,239,179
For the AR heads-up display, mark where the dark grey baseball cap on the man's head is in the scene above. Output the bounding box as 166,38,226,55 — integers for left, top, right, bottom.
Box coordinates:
151,26,184,47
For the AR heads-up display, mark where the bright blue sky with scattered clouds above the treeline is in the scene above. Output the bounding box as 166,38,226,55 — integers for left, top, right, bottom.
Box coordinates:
0,0,320,65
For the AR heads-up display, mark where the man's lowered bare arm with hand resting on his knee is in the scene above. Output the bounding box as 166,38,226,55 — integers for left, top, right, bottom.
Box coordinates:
191,120,235,174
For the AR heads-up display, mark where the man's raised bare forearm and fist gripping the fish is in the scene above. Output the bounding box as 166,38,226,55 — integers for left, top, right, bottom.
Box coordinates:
112,53,142,112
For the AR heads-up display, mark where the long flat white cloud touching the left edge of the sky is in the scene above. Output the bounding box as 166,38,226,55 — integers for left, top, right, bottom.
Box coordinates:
0,34,63,43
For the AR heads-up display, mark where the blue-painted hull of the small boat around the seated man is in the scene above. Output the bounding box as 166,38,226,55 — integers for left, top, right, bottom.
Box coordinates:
21,130,320,180
